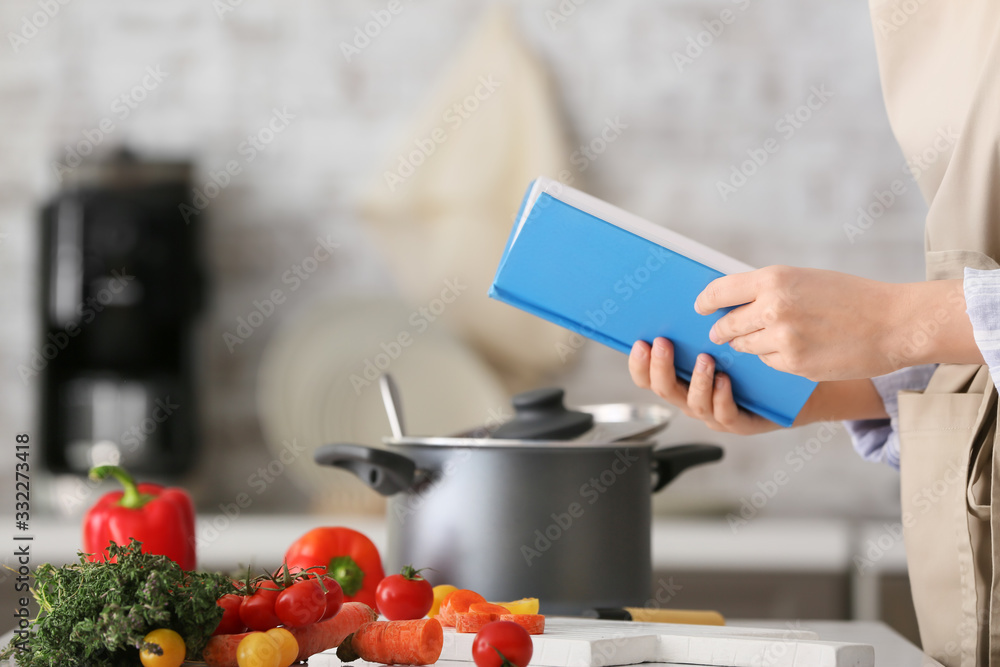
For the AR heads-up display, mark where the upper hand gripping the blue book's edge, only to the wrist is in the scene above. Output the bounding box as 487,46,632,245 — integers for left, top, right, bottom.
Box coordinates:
695,266,904,381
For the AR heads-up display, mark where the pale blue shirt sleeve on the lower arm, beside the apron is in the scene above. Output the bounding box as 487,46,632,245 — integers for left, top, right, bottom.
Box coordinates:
844,366,936,470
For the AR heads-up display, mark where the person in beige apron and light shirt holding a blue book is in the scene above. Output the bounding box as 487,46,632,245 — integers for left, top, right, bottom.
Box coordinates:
629,0,1000,667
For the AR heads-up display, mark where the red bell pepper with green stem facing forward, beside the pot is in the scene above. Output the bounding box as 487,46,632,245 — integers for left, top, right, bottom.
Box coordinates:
285,527,385,609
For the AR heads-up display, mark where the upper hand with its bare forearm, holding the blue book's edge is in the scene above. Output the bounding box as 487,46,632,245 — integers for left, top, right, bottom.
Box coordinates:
695,266,983,381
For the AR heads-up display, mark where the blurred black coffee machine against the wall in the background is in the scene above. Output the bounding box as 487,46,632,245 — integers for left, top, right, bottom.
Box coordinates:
38,152,203,477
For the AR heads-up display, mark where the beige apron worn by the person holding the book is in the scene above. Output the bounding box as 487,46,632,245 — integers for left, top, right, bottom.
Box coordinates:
871,0,1000,667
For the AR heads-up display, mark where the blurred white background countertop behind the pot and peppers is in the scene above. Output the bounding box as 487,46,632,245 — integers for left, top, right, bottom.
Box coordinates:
15,514,906,576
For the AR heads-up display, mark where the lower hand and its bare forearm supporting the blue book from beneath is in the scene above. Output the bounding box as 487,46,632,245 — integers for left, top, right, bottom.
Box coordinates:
628,338,888,435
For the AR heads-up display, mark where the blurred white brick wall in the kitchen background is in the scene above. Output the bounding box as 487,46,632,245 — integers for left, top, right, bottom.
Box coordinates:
0,0,923,515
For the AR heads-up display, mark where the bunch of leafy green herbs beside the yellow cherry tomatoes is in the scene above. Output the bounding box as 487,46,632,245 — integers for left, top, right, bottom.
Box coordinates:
0,539,238,667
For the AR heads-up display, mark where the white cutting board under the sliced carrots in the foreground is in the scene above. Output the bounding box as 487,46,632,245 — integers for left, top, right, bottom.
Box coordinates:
441,616,875,667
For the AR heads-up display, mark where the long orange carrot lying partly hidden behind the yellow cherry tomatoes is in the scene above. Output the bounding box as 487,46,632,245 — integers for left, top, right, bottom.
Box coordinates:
202,602,378,667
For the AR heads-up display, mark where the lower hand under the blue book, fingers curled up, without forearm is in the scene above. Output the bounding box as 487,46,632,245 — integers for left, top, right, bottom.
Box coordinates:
628,338,781,435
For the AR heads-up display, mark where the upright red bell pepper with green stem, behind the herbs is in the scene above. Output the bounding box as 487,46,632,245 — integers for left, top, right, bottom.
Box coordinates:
83,466,197,570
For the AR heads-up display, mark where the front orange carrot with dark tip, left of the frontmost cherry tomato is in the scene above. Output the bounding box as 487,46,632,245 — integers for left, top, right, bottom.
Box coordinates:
337,618,444,665
